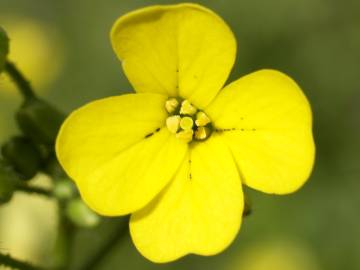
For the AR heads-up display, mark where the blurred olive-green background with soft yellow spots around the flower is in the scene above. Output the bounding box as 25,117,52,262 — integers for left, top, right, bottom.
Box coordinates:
0,0,360,270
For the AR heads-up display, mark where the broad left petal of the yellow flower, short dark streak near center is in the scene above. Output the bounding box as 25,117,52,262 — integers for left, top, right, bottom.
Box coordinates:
56,94,187,215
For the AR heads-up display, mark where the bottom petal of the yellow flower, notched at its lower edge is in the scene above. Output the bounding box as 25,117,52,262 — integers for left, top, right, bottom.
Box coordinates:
130,135,244,263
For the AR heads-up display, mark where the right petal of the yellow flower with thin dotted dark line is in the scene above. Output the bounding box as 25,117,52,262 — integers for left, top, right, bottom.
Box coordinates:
206,70,315,194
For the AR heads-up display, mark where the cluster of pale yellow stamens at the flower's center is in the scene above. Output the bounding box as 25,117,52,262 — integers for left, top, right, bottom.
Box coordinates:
165,98,213,143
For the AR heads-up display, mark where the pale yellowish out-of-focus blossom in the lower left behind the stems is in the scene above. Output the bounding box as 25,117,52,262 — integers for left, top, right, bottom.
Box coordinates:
0,174,58,264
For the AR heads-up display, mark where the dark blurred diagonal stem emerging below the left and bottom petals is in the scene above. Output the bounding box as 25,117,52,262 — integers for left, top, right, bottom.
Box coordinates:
80,219,128,270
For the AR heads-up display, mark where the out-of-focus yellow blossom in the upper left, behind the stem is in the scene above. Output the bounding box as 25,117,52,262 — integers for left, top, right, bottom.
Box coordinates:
0,15,64,93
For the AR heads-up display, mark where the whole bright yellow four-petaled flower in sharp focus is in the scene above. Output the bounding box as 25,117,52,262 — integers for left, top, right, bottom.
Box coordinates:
56,4,314,262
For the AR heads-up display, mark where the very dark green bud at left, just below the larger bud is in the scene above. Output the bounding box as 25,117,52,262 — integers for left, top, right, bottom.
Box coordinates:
1,137,42,180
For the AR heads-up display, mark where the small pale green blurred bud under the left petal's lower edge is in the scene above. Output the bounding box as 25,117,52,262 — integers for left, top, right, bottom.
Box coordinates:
66,198,100,228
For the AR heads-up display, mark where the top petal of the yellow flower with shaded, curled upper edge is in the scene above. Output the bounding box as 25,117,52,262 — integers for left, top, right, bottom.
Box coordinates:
111,4,236,108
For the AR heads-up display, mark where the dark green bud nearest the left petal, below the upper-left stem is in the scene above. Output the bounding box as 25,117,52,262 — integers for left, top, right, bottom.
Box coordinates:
16,98,65,146
